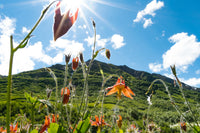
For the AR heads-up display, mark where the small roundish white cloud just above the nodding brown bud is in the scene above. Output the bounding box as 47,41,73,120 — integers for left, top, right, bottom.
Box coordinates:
111,34,125,49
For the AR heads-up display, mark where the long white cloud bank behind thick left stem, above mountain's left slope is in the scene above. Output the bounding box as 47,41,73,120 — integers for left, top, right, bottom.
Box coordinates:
0,16,78,75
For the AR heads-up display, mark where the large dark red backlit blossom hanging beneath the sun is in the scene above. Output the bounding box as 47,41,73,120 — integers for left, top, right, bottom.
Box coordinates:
53,1,79,41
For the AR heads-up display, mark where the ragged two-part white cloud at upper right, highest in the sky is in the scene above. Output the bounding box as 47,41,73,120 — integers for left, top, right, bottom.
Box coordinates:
133,0,164,28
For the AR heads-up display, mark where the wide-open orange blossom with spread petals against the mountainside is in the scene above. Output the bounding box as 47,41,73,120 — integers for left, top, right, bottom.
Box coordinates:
106,76,135,99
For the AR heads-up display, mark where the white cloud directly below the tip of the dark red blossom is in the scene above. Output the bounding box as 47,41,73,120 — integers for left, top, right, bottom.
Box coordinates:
49,38,85,56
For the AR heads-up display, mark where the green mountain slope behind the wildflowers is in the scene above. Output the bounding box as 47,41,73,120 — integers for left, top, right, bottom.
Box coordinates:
0,60,200,130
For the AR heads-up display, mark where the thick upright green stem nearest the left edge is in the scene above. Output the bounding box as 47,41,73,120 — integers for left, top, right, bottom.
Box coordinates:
6,36,14,133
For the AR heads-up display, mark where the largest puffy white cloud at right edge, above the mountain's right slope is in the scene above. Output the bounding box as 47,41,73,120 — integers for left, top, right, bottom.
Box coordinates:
162,32,200,71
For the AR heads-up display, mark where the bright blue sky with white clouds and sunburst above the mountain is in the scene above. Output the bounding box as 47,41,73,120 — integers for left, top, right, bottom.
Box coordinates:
0,0,200,87
